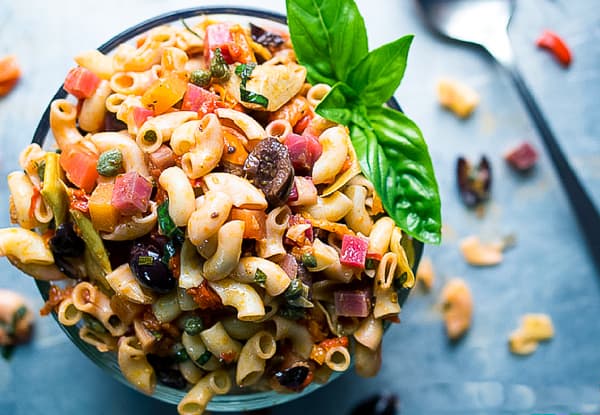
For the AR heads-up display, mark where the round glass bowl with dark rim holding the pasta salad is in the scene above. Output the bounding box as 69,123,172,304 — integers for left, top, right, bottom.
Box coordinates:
32,7,423,412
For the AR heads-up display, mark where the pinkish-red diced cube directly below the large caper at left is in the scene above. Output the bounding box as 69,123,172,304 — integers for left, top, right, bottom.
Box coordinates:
111,171,152,216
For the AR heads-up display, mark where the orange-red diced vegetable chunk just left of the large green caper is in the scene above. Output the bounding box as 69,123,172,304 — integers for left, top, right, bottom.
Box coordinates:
60,144,98,193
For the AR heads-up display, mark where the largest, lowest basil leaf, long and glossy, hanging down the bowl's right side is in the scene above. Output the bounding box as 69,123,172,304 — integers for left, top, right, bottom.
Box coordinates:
350,107,441,244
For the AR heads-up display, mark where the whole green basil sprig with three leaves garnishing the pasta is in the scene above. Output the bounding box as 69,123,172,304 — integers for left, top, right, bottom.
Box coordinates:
286,0,441,244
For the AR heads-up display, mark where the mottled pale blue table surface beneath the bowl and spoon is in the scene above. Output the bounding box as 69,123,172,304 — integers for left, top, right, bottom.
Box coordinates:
0,0,600,415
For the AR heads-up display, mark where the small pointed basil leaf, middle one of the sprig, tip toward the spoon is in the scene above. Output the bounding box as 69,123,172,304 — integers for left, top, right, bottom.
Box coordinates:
347,35,413,107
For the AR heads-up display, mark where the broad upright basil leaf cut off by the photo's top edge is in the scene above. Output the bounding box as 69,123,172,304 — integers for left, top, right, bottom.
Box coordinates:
286,0,369,85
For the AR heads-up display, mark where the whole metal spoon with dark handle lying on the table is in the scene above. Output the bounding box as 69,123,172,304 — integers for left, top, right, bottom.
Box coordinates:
417,0,600,270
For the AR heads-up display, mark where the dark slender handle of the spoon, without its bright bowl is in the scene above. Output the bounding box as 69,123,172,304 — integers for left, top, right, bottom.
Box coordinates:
503,65,600,270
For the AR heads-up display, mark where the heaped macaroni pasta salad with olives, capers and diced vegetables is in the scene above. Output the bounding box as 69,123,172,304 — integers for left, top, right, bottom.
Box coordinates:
0,13,414,414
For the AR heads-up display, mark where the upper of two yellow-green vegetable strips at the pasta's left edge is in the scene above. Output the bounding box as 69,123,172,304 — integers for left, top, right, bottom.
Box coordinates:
40,152,69,227
